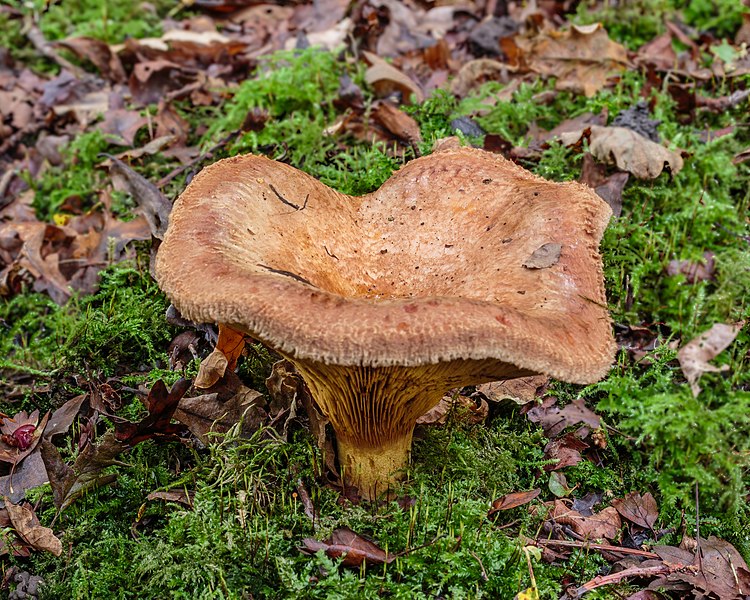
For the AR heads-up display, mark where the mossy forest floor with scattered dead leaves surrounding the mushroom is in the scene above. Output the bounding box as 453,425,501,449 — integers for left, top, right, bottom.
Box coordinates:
0,0,750,600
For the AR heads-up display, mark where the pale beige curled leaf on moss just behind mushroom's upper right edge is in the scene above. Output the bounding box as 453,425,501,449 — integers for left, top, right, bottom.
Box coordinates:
560,125,684,179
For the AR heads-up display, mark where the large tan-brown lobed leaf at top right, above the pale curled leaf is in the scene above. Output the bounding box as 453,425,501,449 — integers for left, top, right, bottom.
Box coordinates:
501,24,629,97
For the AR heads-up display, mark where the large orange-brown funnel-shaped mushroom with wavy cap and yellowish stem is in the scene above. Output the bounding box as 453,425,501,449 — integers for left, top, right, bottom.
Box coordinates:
156,147,615,498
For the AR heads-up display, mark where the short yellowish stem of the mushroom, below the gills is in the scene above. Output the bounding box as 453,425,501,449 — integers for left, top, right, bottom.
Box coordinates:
338,429,413,498
